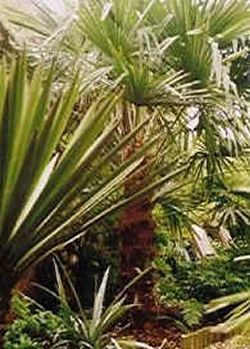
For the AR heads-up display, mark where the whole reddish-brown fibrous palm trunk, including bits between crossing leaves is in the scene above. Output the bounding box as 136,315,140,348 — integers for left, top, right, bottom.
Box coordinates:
117,137,154,305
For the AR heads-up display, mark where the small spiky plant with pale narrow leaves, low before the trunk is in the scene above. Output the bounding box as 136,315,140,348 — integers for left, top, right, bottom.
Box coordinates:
55,264,134,349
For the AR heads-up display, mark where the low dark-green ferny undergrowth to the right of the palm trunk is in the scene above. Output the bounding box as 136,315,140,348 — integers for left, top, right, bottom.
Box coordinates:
155,249,250,327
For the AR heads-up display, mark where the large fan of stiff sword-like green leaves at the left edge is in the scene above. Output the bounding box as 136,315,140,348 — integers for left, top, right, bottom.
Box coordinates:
0,54,182,322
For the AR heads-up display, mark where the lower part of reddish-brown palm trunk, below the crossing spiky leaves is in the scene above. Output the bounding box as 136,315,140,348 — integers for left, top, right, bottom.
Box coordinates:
119,197,154,304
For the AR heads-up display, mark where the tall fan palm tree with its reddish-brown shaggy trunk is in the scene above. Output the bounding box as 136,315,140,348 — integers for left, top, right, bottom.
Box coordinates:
4,0,250,300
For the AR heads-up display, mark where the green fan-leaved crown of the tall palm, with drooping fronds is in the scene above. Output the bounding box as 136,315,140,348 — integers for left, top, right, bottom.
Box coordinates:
2,0,249,207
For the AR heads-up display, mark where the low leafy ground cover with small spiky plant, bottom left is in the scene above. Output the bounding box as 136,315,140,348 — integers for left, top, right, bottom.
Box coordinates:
4,264,151,349
